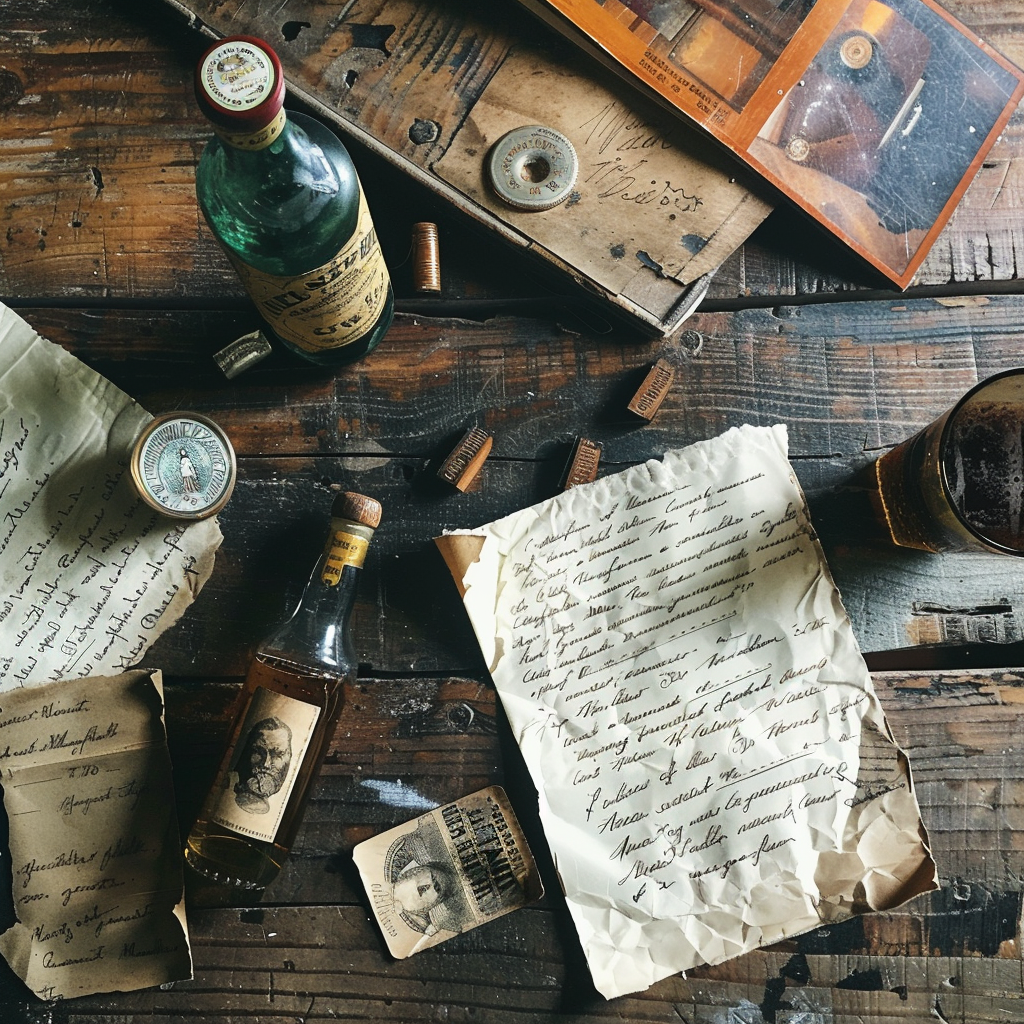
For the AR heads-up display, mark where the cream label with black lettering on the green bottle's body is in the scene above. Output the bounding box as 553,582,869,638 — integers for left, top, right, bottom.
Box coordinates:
227,188,390,352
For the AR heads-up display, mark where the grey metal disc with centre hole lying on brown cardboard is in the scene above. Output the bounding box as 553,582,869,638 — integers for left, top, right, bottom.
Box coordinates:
487,125,580,210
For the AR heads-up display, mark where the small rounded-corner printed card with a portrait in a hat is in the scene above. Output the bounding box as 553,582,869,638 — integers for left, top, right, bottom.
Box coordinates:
352,786,544,959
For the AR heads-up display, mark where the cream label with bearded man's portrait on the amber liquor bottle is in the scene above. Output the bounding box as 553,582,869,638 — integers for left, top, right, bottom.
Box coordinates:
204,688,319,843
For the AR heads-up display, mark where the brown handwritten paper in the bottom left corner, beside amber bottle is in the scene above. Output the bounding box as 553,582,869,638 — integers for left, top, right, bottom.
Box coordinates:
0,671,191,999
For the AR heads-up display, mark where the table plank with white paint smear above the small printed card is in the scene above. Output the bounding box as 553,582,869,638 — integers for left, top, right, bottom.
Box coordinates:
168,670,1024,917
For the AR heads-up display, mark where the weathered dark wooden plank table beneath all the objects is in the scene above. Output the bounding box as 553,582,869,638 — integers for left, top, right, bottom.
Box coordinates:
0,0,1024,1024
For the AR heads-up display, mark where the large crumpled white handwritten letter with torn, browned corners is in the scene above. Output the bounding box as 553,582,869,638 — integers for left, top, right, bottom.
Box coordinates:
437,426,936,997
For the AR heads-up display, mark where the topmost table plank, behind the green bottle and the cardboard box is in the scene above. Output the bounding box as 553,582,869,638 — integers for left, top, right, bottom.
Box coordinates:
0,0,1024,317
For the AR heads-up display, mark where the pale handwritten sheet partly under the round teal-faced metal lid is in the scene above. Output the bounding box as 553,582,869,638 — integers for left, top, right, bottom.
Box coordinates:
0,304,222,692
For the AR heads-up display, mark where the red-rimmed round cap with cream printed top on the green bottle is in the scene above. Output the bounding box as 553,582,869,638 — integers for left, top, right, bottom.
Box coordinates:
196,36,285,134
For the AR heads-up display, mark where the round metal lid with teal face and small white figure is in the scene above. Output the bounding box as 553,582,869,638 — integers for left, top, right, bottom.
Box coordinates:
131,413,236,519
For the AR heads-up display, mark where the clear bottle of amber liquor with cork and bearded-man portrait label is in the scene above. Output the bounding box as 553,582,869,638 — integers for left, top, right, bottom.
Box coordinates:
185,492,381,889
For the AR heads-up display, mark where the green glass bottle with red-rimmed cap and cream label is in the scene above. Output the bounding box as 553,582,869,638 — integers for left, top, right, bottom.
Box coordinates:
196,36,394,366
